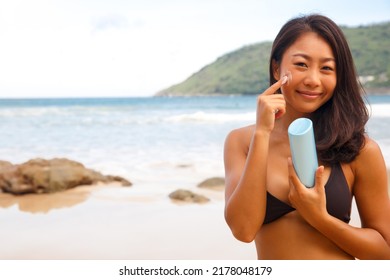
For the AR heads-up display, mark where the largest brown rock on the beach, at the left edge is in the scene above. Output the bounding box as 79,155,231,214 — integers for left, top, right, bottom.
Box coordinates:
0,158,131,194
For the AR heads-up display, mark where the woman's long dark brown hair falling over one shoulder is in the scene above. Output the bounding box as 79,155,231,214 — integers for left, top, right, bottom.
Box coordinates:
269,14,369,164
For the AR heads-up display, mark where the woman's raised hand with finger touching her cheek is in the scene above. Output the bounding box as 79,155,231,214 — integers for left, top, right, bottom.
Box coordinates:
256,76,288,132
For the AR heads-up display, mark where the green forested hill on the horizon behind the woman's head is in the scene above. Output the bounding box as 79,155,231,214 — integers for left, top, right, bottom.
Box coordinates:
157,22,390,95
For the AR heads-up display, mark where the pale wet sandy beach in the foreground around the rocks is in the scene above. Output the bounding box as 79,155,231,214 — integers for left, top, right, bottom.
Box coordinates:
0,166,382,260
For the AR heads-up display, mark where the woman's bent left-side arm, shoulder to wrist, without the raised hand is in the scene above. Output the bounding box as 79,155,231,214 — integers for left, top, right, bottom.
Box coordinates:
225,127,269,242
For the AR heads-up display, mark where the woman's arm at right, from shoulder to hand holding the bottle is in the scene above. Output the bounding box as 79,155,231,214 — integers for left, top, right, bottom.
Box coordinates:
289,139,390,259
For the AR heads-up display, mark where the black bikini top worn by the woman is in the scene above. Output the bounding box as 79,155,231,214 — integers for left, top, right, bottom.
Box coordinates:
264,163,352,224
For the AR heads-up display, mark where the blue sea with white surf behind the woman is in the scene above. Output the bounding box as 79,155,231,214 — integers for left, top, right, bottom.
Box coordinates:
0,95,390,188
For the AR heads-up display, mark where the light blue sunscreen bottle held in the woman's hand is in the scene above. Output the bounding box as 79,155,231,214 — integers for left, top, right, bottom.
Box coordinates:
288,118,318,188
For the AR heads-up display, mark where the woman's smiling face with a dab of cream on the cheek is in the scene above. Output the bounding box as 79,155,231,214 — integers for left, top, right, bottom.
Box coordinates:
274,32,337,114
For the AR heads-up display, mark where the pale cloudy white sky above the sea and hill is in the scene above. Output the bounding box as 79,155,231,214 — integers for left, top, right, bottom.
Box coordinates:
0,0,390,98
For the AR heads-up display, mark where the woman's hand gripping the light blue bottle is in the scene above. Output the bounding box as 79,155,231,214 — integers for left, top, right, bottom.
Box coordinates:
288,158,328,224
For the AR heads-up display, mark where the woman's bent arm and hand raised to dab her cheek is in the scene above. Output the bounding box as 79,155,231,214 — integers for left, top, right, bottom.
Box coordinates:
224,77,285,242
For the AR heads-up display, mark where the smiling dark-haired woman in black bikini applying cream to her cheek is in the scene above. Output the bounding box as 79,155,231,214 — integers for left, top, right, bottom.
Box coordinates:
224,15,390,259
